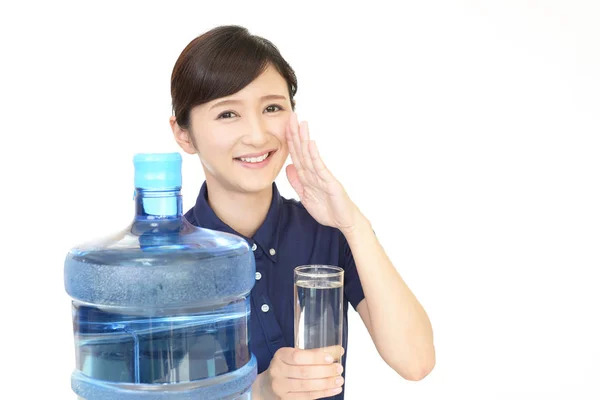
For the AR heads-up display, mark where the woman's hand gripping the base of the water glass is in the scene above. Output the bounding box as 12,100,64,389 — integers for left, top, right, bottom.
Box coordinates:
255,347,344,400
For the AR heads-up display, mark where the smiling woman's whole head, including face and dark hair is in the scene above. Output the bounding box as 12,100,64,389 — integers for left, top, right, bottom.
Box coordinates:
170,27,297,197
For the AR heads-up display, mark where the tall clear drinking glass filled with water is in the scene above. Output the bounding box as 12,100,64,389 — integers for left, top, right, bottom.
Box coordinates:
294,265,344,363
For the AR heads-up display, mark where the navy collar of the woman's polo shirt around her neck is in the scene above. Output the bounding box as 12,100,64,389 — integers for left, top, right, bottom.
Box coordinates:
193,181,283,262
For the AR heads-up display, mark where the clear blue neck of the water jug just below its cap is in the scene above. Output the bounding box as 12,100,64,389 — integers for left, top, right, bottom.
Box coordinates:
135,188,183,220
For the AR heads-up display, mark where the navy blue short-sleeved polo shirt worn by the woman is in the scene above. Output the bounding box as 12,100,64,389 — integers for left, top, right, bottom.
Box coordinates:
185,182,365,400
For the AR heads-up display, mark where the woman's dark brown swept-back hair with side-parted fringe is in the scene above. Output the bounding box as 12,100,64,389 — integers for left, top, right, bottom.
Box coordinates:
171,25,298,129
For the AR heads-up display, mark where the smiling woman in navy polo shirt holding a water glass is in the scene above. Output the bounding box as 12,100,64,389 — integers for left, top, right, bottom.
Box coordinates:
170,26,435,399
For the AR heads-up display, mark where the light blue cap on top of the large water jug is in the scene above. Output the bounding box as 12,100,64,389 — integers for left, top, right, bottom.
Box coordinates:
133,153,182,190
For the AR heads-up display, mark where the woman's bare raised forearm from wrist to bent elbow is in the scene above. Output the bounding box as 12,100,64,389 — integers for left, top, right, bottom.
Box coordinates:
344,214,435,380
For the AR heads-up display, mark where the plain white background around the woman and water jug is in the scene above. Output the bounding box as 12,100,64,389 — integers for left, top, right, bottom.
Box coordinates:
0,0,600,400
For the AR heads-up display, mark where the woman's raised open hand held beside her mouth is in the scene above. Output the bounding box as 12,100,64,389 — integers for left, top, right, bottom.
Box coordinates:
286,113,360,234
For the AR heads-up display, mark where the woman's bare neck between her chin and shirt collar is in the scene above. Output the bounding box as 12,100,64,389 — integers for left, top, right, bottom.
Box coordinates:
206,176,273,237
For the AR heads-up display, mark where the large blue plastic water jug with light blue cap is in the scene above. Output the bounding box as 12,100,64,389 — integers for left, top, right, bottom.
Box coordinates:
64,153,257,400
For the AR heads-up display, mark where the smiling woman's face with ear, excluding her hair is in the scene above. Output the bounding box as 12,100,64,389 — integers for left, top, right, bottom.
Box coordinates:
175,66,292,192
